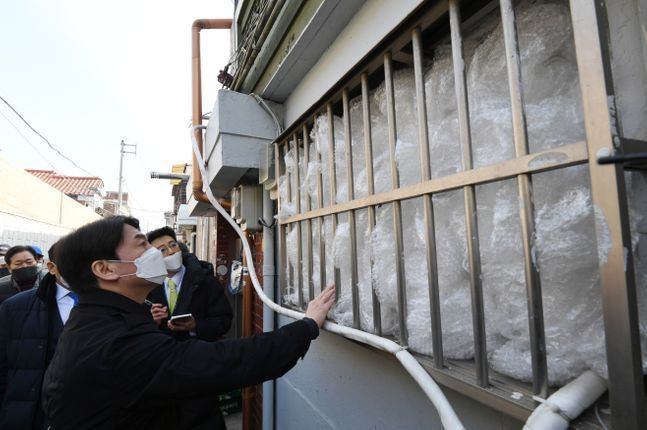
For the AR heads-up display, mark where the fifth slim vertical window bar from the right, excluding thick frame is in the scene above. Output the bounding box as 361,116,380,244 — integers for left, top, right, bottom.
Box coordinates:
361,72,382,336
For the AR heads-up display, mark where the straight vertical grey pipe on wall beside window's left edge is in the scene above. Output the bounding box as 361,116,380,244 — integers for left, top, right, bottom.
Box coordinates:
263,189,276,430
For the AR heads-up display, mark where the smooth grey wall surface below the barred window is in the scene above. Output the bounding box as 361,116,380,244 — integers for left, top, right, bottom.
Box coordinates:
275,317,522,430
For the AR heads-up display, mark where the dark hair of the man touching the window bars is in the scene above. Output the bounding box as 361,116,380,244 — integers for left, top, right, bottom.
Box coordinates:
56,216,139,293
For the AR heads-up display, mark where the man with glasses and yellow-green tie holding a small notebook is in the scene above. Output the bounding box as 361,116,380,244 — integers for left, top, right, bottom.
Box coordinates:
146,227,233,341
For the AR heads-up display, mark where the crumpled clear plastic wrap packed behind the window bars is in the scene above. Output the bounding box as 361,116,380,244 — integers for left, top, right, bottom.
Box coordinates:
279,0,647,385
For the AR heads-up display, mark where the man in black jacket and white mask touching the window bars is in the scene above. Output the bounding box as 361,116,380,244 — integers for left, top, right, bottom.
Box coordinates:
43,216,335,430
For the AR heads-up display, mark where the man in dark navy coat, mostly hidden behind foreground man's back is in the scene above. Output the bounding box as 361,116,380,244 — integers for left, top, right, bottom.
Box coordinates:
0,246,76,430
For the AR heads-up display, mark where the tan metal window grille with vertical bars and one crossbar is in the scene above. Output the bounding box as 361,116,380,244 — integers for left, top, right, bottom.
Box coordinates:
275,0,645,429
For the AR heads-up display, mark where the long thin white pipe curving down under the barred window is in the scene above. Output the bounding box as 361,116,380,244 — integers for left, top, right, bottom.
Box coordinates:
191,126,465,430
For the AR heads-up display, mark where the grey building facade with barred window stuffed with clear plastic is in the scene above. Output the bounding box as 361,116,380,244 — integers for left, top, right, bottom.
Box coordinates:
189,0,647,429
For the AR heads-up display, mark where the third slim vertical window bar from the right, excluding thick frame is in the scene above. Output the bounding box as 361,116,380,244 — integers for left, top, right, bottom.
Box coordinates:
411,28,443,367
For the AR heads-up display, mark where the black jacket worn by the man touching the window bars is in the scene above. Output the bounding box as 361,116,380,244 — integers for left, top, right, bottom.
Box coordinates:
43,290,319,430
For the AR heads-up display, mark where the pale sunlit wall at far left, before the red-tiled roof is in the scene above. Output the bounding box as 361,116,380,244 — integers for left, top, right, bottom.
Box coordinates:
0,156,101,251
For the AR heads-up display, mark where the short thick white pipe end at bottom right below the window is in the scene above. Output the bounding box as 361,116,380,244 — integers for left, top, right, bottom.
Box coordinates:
523,370,607,430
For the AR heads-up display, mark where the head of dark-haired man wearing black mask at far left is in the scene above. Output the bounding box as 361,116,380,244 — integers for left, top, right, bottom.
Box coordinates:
0,245,40,303
